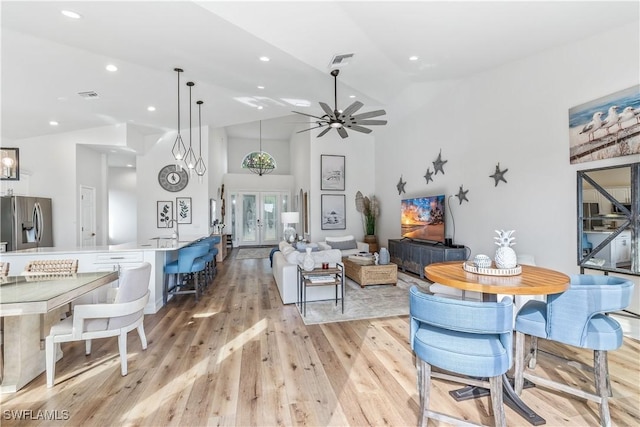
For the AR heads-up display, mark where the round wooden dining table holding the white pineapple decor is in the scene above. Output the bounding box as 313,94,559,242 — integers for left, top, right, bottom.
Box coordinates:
424,261,570,426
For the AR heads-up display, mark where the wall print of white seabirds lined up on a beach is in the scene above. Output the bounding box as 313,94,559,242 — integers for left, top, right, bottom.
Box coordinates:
569,85,640,164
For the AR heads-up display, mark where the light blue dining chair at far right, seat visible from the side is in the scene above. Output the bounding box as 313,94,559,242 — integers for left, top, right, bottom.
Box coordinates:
514,274,633,426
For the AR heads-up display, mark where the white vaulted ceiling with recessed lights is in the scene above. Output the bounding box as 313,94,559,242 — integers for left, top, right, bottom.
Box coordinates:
1,0,639,144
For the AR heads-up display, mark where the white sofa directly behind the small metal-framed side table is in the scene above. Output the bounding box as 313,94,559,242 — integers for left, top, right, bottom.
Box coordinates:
271,241,342,304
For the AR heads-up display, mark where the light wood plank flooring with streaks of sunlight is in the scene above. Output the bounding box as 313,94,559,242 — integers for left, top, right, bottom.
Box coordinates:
0,250,640,426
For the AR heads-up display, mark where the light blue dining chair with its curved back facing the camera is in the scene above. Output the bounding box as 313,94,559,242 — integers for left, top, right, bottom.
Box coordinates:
409,286,513,426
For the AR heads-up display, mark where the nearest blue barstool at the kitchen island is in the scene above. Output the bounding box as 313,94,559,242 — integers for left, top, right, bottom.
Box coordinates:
162,244,209,304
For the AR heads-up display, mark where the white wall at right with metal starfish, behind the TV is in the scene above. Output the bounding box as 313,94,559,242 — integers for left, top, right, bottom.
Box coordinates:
375,22,640,273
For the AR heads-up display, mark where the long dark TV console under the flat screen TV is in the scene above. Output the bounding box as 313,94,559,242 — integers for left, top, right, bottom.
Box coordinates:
388,239,467,279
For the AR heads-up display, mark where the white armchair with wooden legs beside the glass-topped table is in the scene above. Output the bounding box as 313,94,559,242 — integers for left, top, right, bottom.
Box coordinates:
45,262,151,387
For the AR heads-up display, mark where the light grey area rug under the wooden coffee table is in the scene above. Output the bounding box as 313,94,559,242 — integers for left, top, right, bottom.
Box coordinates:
302,272,430,325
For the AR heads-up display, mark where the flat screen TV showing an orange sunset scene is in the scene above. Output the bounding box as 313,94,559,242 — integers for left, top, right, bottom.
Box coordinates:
400,194,445,243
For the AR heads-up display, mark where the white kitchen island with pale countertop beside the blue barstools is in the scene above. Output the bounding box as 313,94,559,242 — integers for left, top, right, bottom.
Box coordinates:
0,236,201,314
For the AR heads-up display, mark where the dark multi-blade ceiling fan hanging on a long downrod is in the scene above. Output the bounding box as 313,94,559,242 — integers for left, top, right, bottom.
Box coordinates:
293,70,387,138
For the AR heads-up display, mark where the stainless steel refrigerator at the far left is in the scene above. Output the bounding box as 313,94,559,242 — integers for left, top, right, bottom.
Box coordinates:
0,196,53,251
